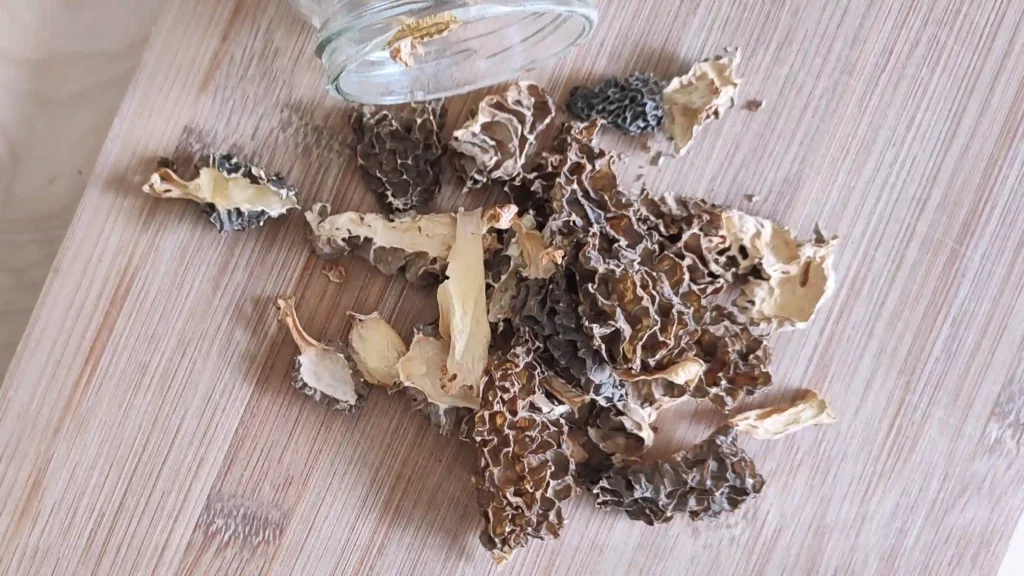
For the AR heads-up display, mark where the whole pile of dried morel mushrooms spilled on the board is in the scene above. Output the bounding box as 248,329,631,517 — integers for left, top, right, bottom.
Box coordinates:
145,55,836,562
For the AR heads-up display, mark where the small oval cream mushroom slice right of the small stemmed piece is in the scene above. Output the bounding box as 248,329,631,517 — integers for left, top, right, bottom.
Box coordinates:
348,312,409,388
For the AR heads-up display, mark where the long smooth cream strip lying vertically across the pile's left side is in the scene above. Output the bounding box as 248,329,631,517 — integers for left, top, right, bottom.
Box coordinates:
437,205,516,396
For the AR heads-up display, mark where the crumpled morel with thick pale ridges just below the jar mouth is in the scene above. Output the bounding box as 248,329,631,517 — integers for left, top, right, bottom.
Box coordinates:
452,82,555,188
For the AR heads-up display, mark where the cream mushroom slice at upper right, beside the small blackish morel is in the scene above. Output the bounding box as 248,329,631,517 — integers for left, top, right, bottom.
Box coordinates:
664,51,739,156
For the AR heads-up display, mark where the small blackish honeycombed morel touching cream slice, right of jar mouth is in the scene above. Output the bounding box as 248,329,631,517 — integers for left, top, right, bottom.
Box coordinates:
566,73,665,135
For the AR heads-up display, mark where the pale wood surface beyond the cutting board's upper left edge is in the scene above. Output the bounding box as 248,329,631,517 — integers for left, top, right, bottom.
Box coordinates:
0,0,163,372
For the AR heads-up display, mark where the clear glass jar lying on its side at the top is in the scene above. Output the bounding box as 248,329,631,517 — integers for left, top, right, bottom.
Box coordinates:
291,0,597,104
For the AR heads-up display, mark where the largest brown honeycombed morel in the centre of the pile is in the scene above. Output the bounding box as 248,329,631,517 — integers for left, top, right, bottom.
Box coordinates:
545,121,728,377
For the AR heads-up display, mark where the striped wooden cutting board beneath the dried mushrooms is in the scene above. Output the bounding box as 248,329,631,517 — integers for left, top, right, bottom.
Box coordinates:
0,0,1024,575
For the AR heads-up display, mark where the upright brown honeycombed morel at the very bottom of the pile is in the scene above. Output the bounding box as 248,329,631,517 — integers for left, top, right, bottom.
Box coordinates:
463,333,575,563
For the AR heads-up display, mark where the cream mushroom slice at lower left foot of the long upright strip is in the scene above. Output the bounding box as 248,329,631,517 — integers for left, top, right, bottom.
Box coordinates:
397,328,480,436
